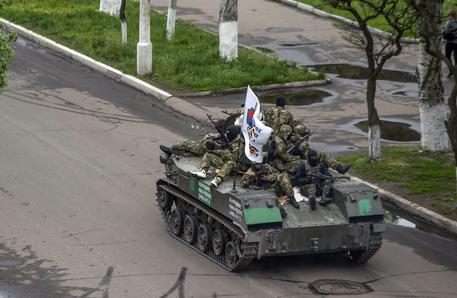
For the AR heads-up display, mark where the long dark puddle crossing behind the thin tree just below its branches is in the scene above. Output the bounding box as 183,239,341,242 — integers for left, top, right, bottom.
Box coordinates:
310,63,417,83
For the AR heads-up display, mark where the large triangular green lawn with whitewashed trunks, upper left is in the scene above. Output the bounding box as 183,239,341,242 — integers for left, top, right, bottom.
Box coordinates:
0,0,323,91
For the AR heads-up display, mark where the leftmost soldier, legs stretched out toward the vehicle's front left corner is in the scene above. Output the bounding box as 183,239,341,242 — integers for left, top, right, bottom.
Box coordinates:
159,120,227,156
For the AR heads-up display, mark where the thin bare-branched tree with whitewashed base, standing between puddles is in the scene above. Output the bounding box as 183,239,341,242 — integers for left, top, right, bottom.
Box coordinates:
324,0,414,161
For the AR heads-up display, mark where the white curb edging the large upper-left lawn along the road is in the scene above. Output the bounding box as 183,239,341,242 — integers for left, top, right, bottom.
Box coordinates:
0,18,172,100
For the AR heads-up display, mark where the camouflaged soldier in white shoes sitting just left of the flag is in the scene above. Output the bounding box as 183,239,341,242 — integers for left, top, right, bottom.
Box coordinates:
192,125,241,187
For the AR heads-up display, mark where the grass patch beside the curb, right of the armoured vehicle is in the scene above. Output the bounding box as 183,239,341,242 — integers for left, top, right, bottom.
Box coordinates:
339,147,457,219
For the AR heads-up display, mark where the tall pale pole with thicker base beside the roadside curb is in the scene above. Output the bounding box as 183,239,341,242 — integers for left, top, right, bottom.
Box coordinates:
136,0,152,76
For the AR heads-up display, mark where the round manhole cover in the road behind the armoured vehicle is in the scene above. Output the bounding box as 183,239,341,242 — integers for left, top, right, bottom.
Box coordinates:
309,279,373,295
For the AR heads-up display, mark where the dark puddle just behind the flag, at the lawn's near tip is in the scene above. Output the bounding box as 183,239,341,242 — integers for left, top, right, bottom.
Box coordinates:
260,89,332,106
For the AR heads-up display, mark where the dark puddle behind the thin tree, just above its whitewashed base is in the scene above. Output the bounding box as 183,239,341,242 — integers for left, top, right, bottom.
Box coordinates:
354,120,421,142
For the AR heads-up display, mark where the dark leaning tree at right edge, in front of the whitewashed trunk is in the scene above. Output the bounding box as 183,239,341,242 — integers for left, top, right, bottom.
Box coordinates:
407,0,457,189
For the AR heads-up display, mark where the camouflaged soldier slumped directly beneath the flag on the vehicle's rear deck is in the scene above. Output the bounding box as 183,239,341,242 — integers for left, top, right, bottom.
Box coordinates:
241,164,300,209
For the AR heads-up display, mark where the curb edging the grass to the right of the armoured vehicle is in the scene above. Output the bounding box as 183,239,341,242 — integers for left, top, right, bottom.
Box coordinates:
350,176,457,239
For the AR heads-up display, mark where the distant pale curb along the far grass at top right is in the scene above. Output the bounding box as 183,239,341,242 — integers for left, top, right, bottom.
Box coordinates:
271,0,419,44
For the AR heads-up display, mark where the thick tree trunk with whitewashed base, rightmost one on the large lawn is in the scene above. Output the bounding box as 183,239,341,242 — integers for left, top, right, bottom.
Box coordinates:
219,0,238,61
